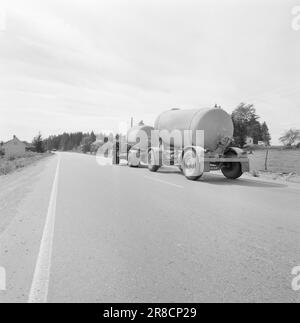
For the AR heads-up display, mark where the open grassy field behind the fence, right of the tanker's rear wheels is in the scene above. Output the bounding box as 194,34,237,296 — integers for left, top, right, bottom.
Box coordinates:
249,149,300,175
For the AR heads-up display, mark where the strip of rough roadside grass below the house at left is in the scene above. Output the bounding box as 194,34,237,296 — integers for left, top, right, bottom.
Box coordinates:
0,152,51,176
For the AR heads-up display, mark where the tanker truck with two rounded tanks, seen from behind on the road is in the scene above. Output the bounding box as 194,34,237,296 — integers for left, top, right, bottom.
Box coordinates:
127,108,249,180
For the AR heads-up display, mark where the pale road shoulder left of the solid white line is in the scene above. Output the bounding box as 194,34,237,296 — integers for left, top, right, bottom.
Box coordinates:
0,156,57,303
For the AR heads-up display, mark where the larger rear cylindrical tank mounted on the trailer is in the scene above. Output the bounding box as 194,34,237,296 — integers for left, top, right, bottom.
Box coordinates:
155,108,234,151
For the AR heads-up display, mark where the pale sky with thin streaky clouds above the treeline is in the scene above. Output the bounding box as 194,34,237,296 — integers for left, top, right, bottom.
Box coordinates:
0,0,300,143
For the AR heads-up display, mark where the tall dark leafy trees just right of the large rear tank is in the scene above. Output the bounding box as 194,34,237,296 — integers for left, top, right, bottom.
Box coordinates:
232,103,271,147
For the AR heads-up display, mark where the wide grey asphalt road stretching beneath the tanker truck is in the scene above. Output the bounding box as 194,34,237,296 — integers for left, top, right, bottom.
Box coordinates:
0,153,300,302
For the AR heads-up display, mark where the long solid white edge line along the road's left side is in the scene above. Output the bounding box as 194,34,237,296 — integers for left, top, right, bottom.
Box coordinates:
28,155,61,303
